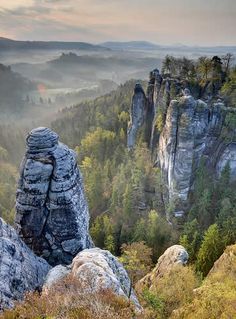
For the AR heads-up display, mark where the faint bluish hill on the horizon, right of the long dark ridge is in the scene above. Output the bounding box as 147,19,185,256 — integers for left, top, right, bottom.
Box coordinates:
100,41,160,50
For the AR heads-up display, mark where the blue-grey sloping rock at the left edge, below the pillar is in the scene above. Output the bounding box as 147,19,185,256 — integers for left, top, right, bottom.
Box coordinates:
0,218,51,310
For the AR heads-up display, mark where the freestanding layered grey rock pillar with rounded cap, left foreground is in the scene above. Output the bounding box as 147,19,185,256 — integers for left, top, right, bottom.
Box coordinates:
15,127,92,265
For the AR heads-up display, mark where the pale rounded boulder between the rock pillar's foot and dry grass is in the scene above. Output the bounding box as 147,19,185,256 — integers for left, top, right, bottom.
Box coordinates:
44,248,141,309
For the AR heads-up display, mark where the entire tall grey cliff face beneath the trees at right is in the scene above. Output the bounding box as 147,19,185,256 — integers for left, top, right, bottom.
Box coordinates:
128,70,236,215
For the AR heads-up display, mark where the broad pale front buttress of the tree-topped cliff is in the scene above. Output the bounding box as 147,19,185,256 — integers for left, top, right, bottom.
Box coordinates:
158,89,223,207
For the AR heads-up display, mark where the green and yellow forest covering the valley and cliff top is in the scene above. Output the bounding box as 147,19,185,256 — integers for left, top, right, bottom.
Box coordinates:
0,54,236,318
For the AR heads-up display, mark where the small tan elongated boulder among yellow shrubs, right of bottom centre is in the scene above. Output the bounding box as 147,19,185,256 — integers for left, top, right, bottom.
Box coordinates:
135,245,188,291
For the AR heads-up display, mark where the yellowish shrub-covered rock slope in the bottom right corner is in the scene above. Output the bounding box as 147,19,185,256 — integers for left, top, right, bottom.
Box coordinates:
170,245,236,319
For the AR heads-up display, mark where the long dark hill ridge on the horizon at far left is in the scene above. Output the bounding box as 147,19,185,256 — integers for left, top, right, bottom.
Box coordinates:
0,37,109,51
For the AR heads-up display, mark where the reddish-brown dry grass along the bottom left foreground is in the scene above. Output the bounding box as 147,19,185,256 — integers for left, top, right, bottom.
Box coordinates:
0,277,135,319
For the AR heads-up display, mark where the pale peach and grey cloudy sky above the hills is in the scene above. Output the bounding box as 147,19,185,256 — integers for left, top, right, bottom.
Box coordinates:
0,0,236,46
